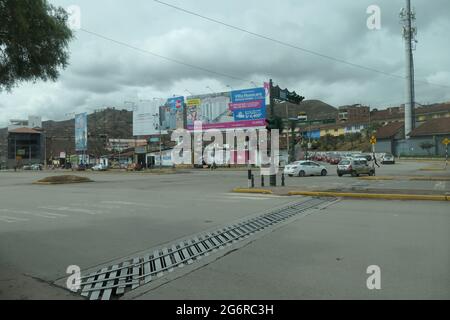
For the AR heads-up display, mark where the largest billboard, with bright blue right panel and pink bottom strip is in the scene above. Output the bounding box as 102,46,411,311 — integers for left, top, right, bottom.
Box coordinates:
186,88,266,130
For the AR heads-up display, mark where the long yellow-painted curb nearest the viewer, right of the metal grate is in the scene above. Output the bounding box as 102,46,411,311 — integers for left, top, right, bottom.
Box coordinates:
288,191,450,201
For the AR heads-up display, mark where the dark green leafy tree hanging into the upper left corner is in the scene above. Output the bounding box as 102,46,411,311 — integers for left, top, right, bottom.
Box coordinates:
0,0,73,91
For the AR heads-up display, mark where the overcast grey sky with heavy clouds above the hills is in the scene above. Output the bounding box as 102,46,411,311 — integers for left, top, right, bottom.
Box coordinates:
0,0,450,126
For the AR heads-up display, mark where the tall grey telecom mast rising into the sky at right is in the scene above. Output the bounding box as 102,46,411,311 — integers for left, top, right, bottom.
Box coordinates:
400,0,417,139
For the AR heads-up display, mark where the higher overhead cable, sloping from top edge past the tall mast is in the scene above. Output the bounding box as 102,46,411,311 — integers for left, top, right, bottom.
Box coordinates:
153,0,450,88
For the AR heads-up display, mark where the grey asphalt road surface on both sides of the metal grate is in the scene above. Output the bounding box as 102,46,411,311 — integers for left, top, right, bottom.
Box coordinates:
0,163,450,299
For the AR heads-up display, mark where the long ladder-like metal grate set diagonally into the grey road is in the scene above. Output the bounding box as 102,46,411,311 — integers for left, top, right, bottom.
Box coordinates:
75,198,335,300
